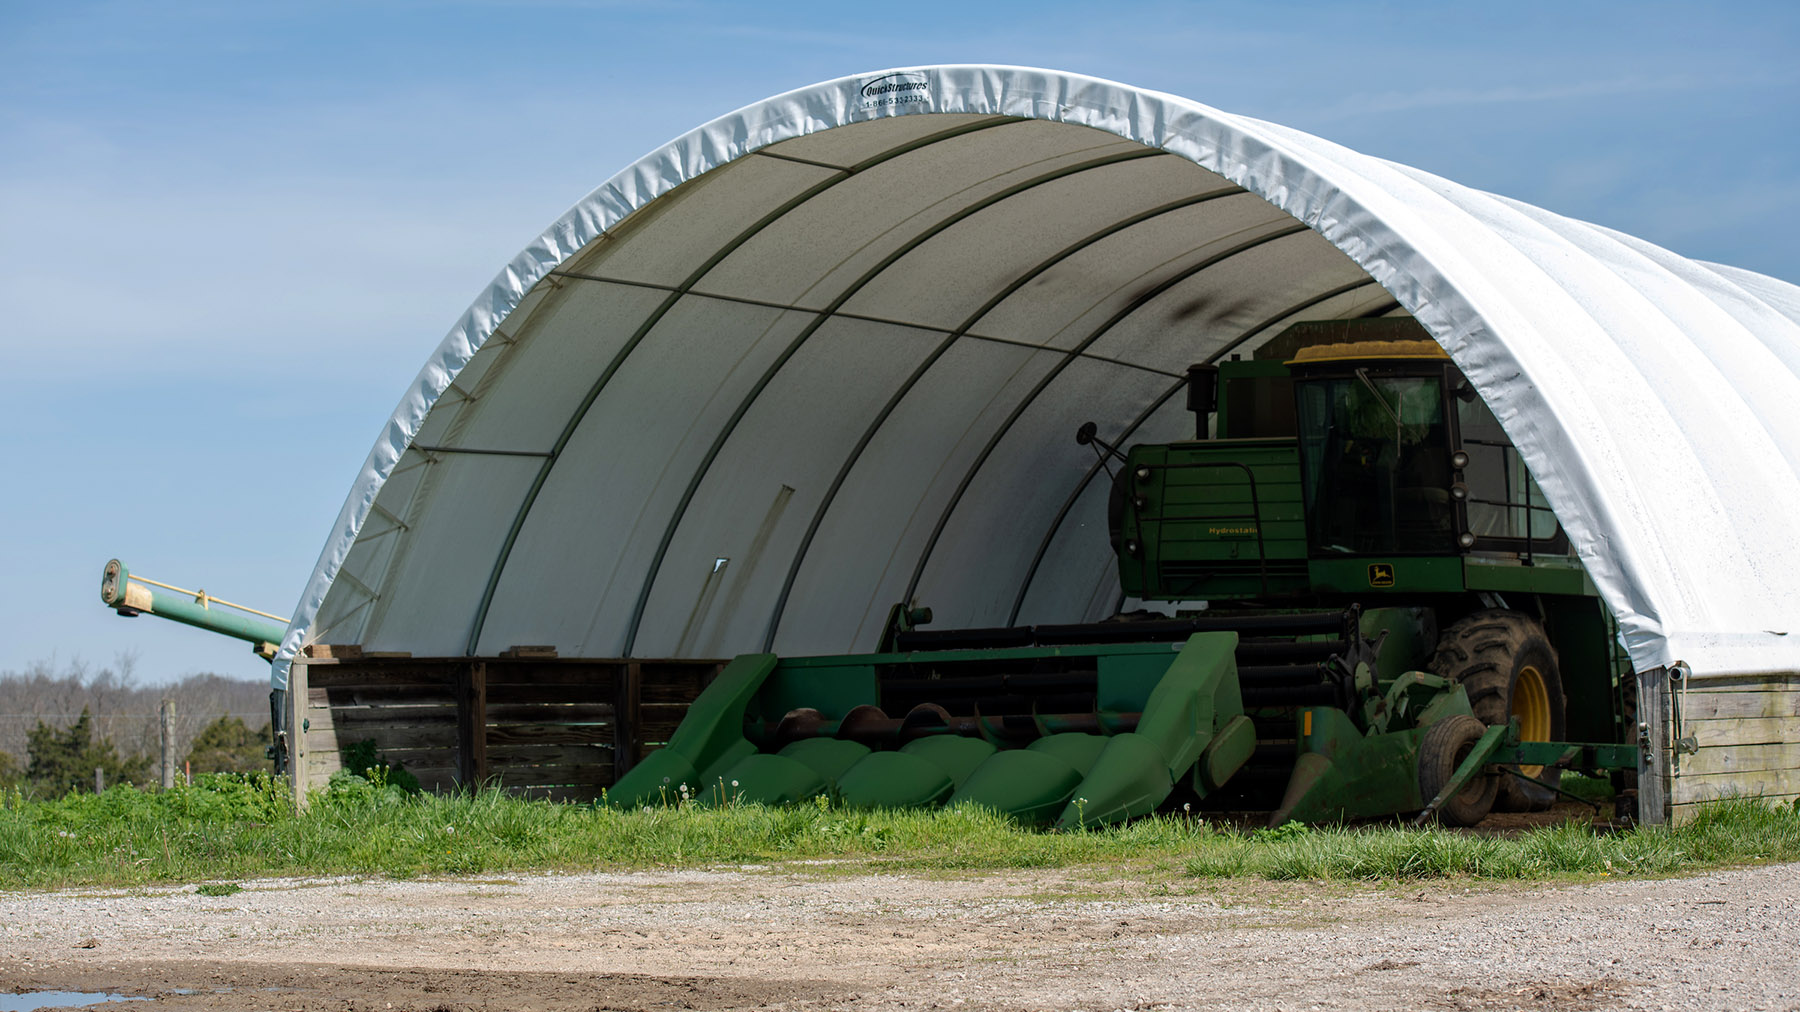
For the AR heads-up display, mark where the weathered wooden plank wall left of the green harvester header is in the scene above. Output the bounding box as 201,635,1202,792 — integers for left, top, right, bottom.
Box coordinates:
288,655,724,803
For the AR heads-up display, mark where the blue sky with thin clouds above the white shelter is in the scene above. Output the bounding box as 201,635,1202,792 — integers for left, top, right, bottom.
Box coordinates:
0,0,1800,682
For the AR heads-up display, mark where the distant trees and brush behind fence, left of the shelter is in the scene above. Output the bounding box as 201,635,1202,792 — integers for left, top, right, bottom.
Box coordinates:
0,657,270,796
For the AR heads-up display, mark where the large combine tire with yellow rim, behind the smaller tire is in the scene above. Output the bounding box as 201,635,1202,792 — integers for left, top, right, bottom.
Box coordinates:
1431,609,1568,812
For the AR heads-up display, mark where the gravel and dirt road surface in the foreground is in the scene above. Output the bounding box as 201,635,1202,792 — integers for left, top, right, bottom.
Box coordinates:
0,864,1800,1012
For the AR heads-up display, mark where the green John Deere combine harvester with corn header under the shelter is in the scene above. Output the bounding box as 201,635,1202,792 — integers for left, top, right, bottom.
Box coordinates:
610,319,1638,828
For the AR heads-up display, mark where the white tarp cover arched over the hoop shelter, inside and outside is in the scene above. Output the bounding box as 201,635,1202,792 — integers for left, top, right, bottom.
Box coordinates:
274,67,1800,688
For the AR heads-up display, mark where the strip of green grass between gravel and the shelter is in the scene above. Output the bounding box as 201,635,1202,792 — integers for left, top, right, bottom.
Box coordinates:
0,774,1800,895
